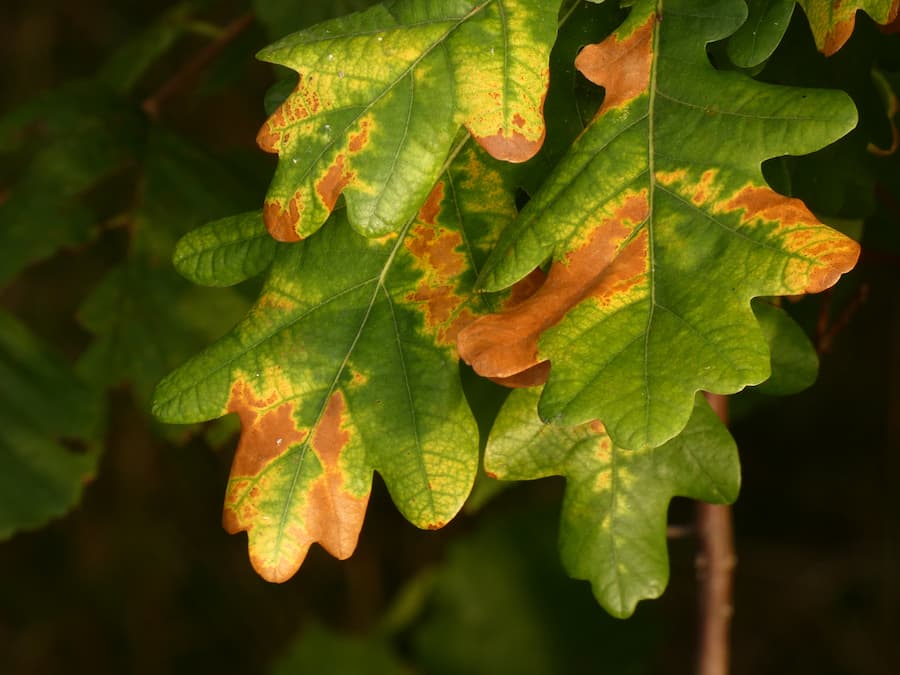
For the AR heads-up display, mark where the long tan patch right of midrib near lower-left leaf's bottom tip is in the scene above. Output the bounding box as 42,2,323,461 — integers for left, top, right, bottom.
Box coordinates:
303,391,369,560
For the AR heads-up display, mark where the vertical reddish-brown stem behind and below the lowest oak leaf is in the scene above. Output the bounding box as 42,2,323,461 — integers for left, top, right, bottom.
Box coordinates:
696,394,737,675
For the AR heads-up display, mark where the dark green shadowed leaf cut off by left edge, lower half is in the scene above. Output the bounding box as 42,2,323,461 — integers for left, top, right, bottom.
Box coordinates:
0,312,104,539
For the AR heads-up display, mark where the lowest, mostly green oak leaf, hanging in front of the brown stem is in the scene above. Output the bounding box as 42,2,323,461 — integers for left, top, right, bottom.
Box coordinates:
484,389,740,618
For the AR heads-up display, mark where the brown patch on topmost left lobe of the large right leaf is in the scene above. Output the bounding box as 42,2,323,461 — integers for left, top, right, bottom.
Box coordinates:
575,14,656,115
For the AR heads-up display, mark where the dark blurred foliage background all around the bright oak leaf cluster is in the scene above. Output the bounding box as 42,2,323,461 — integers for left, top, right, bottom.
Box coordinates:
0,0,900,675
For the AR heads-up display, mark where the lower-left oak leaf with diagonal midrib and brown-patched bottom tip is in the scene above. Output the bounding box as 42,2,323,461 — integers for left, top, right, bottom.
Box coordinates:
155,143,515,581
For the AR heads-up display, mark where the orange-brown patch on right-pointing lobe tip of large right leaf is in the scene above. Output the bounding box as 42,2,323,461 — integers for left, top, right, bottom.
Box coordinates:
725,185,859,294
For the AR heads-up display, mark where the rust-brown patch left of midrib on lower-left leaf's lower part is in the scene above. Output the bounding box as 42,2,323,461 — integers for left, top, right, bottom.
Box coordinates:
228,380,307,479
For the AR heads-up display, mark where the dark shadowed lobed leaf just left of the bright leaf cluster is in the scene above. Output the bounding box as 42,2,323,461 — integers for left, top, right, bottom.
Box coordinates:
78,132,255,406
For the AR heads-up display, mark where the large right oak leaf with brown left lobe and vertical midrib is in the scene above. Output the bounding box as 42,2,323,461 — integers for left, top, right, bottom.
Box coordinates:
459,0,858,449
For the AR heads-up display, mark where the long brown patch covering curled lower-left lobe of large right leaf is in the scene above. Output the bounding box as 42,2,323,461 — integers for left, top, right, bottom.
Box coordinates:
457,193,649,381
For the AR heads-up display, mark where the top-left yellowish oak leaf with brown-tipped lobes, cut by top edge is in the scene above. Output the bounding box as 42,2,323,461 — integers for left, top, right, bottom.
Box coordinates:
258,0,559,241
